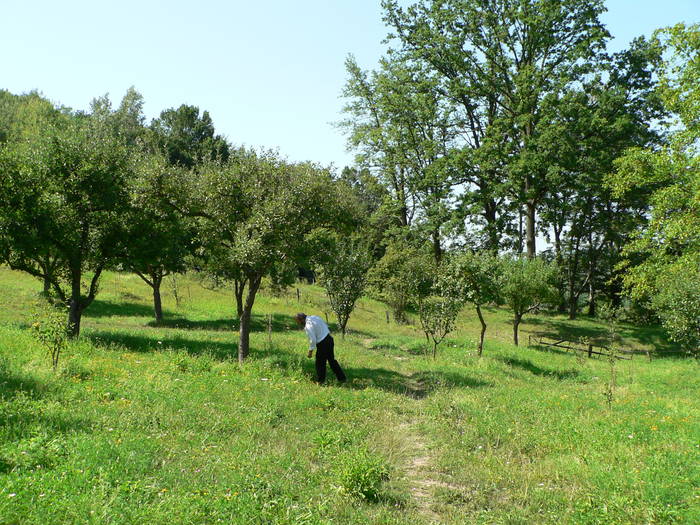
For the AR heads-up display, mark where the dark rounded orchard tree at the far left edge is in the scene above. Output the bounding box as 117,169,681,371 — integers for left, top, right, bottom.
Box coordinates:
0,109,133,336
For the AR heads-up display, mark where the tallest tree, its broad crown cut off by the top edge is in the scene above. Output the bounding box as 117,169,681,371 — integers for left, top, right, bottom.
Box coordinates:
382,0,608,257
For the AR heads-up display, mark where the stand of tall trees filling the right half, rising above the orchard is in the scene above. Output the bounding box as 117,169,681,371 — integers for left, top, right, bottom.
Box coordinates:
340,0,700,349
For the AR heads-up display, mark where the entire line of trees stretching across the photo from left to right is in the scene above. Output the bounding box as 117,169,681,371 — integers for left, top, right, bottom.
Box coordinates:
0,0,700,360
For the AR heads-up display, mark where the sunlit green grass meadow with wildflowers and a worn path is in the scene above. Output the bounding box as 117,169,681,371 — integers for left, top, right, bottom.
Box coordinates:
0,269,700,525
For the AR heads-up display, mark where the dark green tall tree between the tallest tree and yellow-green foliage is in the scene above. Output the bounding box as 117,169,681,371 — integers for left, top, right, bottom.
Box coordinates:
541,39,662,318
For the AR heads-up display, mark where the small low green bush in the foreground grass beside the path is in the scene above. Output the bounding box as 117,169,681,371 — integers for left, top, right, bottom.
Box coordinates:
338,449,389,501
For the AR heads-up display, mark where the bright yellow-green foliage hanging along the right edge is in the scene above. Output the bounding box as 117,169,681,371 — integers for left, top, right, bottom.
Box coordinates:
609,24,700,350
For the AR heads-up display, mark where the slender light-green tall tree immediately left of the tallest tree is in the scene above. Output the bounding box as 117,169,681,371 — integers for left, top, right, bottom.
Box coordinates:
343,57,455,261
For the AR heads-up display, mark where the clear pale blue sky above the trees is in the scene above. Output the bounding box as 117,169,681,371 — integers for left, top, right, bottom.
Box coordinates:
0,0,700,168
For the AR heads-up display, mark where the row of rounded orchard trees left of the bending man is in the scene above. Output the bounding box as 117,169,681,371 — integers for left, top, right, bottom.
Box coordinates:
0,89,359,360
